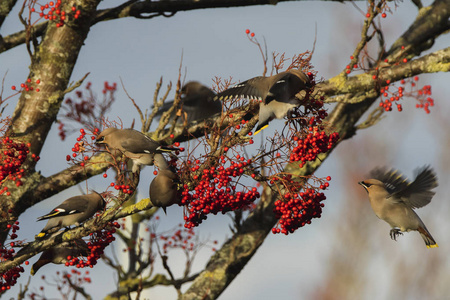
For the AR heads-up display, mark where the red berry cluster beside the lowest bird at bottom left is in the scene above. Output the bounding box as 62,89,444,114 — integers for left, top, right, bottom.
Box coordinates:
65,222,120,268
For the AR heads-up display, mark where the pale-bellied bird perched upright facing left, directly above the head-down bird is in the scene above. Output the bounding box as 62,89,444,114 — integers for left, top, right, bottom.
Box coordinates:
95,127,180,173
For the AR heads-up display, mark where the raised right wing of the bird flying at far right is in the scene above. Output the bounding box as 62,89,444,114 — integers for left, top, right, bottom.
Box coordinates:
395,166,438,208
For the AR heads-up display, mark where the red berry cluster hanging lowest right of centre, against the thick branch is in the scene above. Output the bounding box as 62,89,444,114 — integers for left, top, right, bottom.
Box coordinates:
272,189,326,235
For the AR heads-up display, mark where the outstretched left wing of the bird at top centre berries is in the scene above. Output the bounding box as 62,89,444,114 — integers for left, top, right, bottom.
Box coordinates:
214,76,270,101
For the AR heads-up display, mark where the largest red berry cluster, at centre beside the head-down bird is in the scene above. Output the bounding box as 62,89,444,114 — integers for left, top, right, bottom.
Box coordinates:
180,155,260,228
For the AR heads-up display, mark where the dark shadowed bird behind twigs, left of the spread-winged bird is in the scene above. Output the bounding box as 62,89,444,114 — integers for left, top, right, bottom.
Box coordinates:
157,81,222,123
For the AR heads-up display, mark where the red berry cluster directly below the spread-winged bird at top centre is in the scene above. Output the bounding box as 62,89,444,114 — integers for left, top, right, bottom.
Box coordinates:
289,131,339,168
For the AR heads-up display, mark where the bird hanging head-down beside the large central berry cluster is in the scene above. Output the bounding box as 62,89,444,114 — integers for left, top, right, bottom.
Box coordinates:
149,154,180,213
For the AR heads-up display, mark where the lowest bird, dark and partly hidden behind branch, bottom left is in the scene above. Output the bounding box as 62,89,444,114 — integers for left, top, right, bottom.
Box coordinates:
30,239,91,275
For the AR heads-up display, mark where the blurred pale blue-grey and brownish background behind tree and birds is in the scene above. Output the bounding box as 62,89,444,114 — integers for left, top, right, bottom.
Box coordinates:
0,1,450,299
